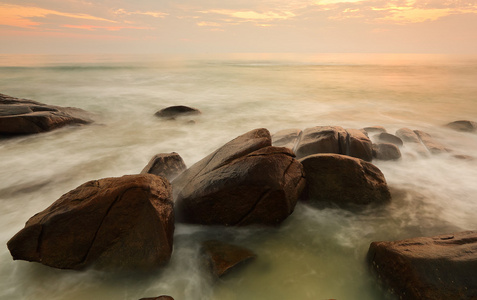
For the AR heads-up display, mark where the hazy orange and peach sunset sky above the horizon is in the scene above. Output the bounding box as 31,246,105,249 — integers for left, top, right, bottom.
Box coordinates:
0,0,477,54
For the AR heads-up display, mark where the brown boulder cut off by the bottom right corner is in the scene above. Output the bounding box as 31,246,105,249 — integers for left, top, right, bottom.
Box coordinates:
367,231,477,300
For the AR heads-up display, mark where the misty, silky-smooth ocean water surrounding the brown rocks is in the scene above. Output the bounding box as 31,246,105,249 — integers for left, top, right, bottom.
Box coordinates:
0,54,477,300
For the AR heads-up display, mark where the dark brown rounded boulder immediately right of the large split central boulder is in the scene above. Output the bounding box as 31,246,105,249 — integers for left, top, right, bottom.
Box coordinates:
299,154,391,208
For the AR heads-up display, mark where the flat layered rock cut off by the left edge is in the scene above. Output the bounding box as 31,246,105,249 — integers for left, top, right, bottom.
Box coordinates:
0,94,93,136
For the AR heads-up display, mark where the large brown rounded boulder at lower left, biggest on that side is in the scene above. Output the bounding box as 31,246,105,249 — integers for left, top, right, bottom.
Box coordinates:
7,174,174,270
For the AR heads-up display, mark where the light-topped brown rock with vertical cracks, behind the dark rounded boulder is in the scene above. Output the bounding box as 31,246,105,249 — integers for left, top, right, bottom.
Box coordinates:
294,126,373,161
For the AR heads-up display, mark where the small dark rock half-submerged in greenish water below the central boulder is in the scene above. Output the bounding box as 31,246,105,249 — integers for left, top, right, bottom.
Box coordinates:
202,240,256,277
